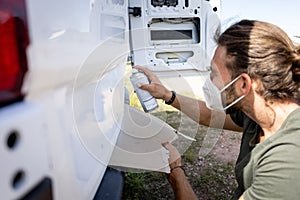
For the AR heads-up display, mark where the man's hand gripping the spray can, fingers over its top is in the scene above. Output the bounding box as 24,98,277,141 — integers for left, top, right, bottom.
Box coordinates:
133,66,172,101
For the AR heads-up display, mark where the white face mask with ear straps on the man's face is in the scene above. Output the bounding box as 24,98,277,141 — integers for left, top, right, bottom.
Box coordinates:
202,75,245,112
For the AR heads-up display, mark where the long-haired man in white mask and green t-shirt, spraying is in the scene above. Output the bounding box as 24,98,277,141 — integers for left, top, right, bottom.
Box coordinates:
136,20,300,199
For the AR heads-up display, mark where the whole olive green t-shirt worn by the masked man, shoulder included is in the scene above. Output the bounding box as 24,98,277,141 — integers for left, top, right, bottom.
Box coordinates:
243,108,300,200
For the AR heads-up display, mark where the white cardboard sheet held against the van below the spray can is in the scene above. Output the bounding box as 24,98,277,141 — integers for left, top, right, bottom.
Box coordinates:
109,105,177,173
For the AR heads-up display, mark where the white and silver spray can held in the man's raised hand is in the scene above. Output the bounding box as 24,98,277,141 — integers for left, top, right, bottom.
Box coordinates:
130,69,158,112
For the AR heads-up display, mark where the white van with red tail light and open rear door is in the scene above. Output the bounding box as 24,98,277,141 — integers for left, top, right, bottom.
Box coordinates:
0,0,220,200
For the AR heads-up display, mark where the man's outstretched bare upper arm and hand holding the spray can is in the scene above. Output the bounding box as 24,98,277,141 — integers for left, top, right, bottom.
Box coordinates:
135,66,242,131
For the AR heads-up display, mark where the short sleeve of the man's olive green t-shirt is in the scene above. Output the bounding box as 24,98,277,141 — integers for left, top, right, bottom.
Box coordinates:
243,141,300,200
